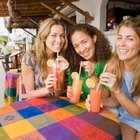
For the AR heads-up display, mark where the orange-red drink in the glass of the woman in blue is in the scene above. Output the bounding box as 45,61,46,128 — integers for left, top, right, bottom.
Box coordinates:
90,88,101,112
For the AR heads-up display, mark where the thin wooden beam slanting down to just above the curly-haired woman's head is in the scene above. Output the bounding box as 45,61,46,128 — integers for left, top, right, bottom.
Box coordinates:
40,3,77,26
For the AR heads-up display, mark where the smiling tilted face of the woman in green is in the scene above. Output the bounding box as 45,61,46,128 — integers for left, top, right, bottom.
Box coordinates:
71,31,96,60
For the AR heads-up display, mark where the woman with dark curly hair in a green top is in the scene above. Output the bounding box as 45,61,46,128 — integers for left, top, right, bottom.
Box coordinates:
66,24,112,99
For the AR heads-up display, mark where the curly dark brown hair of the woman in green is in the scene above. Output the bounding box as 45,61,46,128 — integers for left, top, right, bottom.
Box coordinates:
66,24,112,69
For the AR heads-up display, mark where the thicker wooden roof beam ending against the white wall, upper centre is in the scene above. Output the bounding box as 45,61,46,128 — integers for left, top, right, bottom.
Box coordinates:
60,0,94,21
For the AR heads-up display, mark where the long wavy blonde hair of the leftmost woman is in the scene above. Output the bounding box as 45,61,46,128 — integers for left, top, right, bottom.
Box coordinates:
31,18,68,73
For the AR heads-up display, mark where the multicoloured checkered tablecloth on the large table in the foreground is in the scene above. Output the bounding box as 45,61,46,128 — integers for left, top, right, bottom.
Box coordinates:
0,98,121,140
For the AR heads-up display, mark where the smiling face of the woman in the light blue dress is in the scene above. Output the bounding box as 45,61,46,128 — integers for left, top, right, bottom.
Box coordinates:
116,26,140,62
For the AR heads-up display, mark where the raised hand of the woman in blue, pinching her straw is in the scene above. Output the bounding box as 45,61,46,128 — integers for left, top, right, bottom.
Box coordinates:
100,72,120,93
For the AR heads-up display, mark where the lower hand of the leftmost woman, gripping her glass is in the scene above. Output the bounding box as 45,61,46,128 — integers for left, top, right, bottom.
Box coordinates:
45,74,57,93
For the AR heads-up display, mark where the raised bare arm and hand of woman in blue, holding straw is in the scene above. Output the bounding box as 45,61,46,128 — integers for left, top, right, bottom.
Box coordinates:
101,72,140,117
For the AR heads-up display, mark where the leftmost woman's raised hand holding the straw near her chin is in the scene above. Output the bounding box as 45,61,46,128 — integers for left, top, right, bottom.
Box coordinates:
56,56,69,72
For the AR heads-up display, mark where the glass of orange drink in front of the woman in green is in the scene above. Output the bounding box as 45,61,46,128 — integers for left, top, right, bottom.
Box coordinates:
70,77,83,103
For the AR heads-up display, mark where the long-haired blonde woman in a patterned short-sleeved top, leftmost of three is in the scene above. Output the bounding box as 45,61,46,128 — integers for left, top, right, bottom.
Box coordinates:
22,18,69,98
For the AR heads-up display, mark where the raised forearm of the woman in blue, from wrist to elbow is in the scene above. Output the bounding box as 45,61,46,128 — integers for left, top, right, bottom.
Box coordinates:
115,90,140,117
